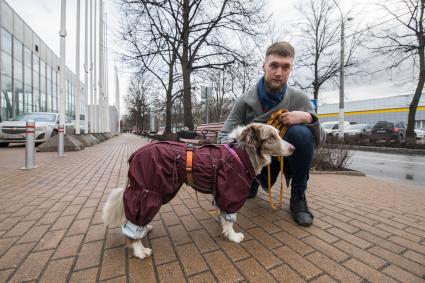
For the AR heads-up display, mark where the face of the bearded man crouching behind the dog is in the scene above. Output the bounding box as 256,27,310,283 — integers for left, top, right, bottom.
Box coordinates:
263,54,293,94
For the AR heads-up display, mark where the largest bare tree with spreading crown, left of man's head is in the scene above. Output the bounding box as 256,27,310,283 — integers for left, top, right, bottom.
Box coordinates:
121,0,266,129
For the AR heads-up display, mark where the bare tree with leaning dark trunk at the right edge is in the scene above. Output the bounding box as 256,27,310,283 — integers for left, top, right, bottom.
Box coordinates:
371,0,425,143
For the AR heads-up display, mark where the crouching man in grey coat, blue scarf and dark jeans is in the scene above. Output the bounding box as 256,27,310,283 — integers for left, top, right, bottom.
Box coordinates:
218,42,325,229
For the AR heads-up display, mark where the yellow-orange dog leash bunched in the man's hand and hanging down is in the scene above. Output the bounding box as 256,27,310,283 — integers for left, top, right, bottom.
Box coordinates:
267,108,288,209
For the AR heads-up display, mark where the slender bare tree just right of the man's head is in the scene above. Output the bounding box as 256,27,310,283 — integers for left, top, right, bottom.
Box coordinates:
296,0,360,106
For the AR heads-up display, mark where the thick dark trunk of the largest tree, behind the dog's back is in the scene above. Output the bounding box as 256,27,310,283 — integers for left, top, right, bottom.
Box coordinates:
181,0,193,131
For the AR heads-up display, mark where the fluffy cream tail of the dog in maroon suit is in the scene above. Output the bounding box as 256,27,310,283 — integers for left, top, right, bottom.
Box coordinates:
102,179,128,229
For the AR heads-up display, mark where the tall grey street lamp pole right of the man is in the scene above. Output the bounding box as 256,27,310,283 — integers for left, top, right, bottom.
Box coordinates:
334,0,353,142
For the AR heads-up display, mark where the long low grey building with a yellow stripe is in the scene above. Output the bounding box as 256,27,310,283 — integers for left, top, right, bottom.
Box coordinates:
318,94,425,128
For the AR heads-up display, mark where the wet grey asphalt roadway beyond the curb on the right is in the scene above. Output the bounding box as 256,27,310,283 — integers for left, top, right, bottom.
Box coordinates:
348,151,425,188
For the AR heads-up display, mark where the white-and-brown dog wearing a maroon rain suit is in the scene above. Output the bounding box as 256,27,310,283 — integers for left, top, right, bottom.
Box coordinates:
102,123,295,259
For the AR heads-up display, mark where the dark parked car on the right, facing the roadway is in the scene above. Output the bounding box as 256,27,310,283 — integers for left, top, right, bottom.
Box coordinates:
370,121,407,142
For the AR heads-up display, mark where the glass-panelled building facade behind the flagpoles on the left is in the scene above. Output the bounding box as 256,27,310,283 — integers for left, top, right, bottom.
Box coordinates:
0,0,84,122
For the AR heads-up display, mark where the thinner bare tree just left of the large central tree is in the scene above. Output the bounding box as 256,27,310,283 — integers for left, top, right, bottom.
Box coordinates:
121,0,181,135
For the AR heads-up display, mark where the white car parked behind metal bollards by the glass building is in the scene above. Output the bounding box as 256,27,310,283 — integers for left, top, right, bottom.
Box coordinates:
0,112,74,147
